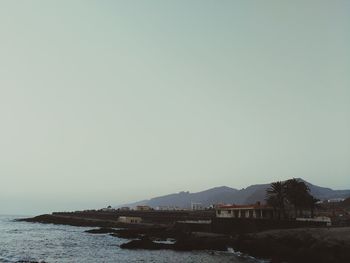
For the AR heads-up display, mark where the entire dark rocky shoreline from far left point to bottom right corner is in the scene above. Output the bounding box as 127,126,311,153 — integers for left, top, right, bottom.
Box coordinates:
20,215,350,263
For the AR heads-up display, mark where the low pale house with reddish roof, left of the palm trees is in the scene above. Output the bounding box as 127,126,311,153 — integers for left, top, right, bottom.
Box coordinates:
216,203,274,219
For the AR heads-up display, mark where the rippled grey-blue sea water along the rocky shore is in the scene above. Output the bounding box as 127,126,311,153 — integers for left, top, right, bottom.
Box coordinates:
0,216,262,263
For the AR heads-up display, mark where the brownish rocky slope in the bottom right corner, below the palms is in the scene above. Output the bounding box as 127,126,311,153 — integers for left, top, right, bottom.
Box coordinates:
233,228,350,263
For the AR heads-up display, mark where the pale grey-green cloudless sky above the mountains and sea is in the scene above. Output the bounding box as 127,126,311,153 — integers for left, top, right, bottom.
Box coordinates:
0,0,350,215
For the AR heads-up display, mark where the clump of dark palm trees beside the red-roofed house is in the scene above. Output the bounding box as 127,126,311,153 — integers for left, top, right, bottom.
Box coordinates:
266,178,318,218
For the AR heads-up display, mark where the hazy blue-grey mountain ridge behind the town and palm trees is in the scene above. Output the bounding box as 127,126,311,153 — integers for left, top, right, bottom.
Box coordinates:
119,178,350,208
